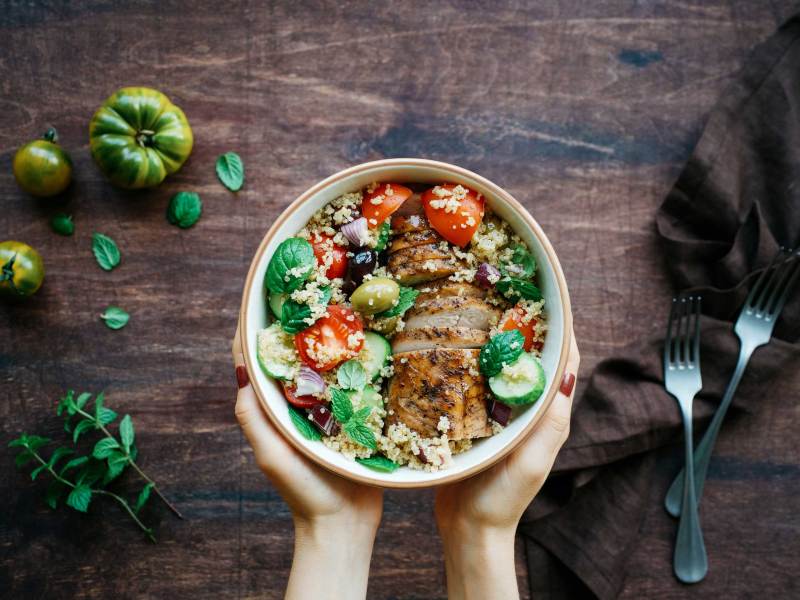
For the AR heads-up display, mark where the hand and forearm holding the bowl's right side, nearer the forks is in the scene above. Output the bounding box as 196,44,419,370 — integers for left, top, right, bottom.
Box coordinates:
435,333,580,600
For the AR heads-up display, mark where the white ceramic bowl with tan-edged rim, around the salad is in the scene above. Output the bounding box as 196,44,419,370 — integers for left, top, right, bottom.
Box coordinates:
241,158,572,488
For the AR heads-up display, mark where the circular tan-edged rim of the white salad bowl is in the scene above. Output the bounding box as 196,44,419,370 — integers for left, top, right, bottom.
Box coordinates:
239,158,572,489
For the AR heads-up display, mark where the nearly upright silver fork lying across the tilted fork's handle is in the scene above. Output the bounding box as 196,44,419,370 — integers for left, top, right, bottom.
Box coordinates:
664,296,708,583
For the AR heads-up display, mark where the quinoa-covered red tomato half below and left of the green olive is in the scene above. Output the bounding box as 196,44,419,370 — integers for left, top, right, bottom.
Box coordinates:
294,304,364,371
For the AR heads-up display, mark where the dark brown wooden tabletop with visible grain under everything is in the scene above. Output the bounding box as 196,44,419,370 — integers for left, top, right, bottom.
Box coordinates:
0,0,800,599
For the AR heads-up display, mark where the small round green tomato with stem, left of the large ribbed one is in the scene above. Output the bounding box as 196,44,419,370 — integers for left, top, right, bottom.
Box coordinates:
13,127,72,197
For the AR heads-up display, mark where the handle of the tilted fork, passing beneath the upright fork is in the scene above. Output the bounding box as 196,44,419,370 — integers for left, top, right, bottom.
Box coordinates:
664,344,755,517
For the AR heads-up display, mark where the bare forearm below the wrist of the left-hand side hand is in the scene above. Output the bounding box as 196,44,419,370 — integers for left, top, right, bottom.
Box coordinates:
286,521,376,600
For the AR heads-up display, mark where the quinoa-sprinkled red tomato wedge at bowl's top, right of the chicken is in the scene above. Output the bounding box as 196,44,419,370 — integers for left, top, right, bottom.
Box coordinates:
422,183,484,247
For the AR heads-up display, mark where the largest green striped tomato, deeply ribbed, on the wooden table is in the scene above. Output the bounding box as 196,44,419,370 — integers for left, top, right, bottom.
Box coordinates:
89,87,194,188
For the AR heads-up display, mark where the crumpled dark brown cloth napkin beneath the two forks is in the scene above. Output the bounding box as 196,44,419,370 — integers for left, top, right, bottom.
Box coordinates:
519,15,800,599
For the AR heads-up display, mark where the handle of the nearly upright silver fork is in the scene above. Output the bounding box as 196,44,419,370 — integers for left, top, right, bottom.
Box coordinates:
672,412,708,583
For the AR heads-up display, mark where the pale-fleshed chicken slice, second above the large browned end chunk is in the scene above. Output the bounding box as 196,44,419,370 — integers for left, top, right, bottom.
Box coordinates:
405,296,502,331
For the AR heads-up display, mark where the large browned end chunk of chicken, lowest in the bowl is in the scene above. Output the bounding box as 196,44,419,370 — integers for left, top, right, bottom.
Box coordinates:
387,348,492,440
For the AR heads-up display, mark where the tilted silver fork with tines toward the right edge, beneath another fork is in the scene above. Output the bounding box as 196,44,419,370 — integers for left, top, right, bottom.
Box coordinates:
664,248,800,517
